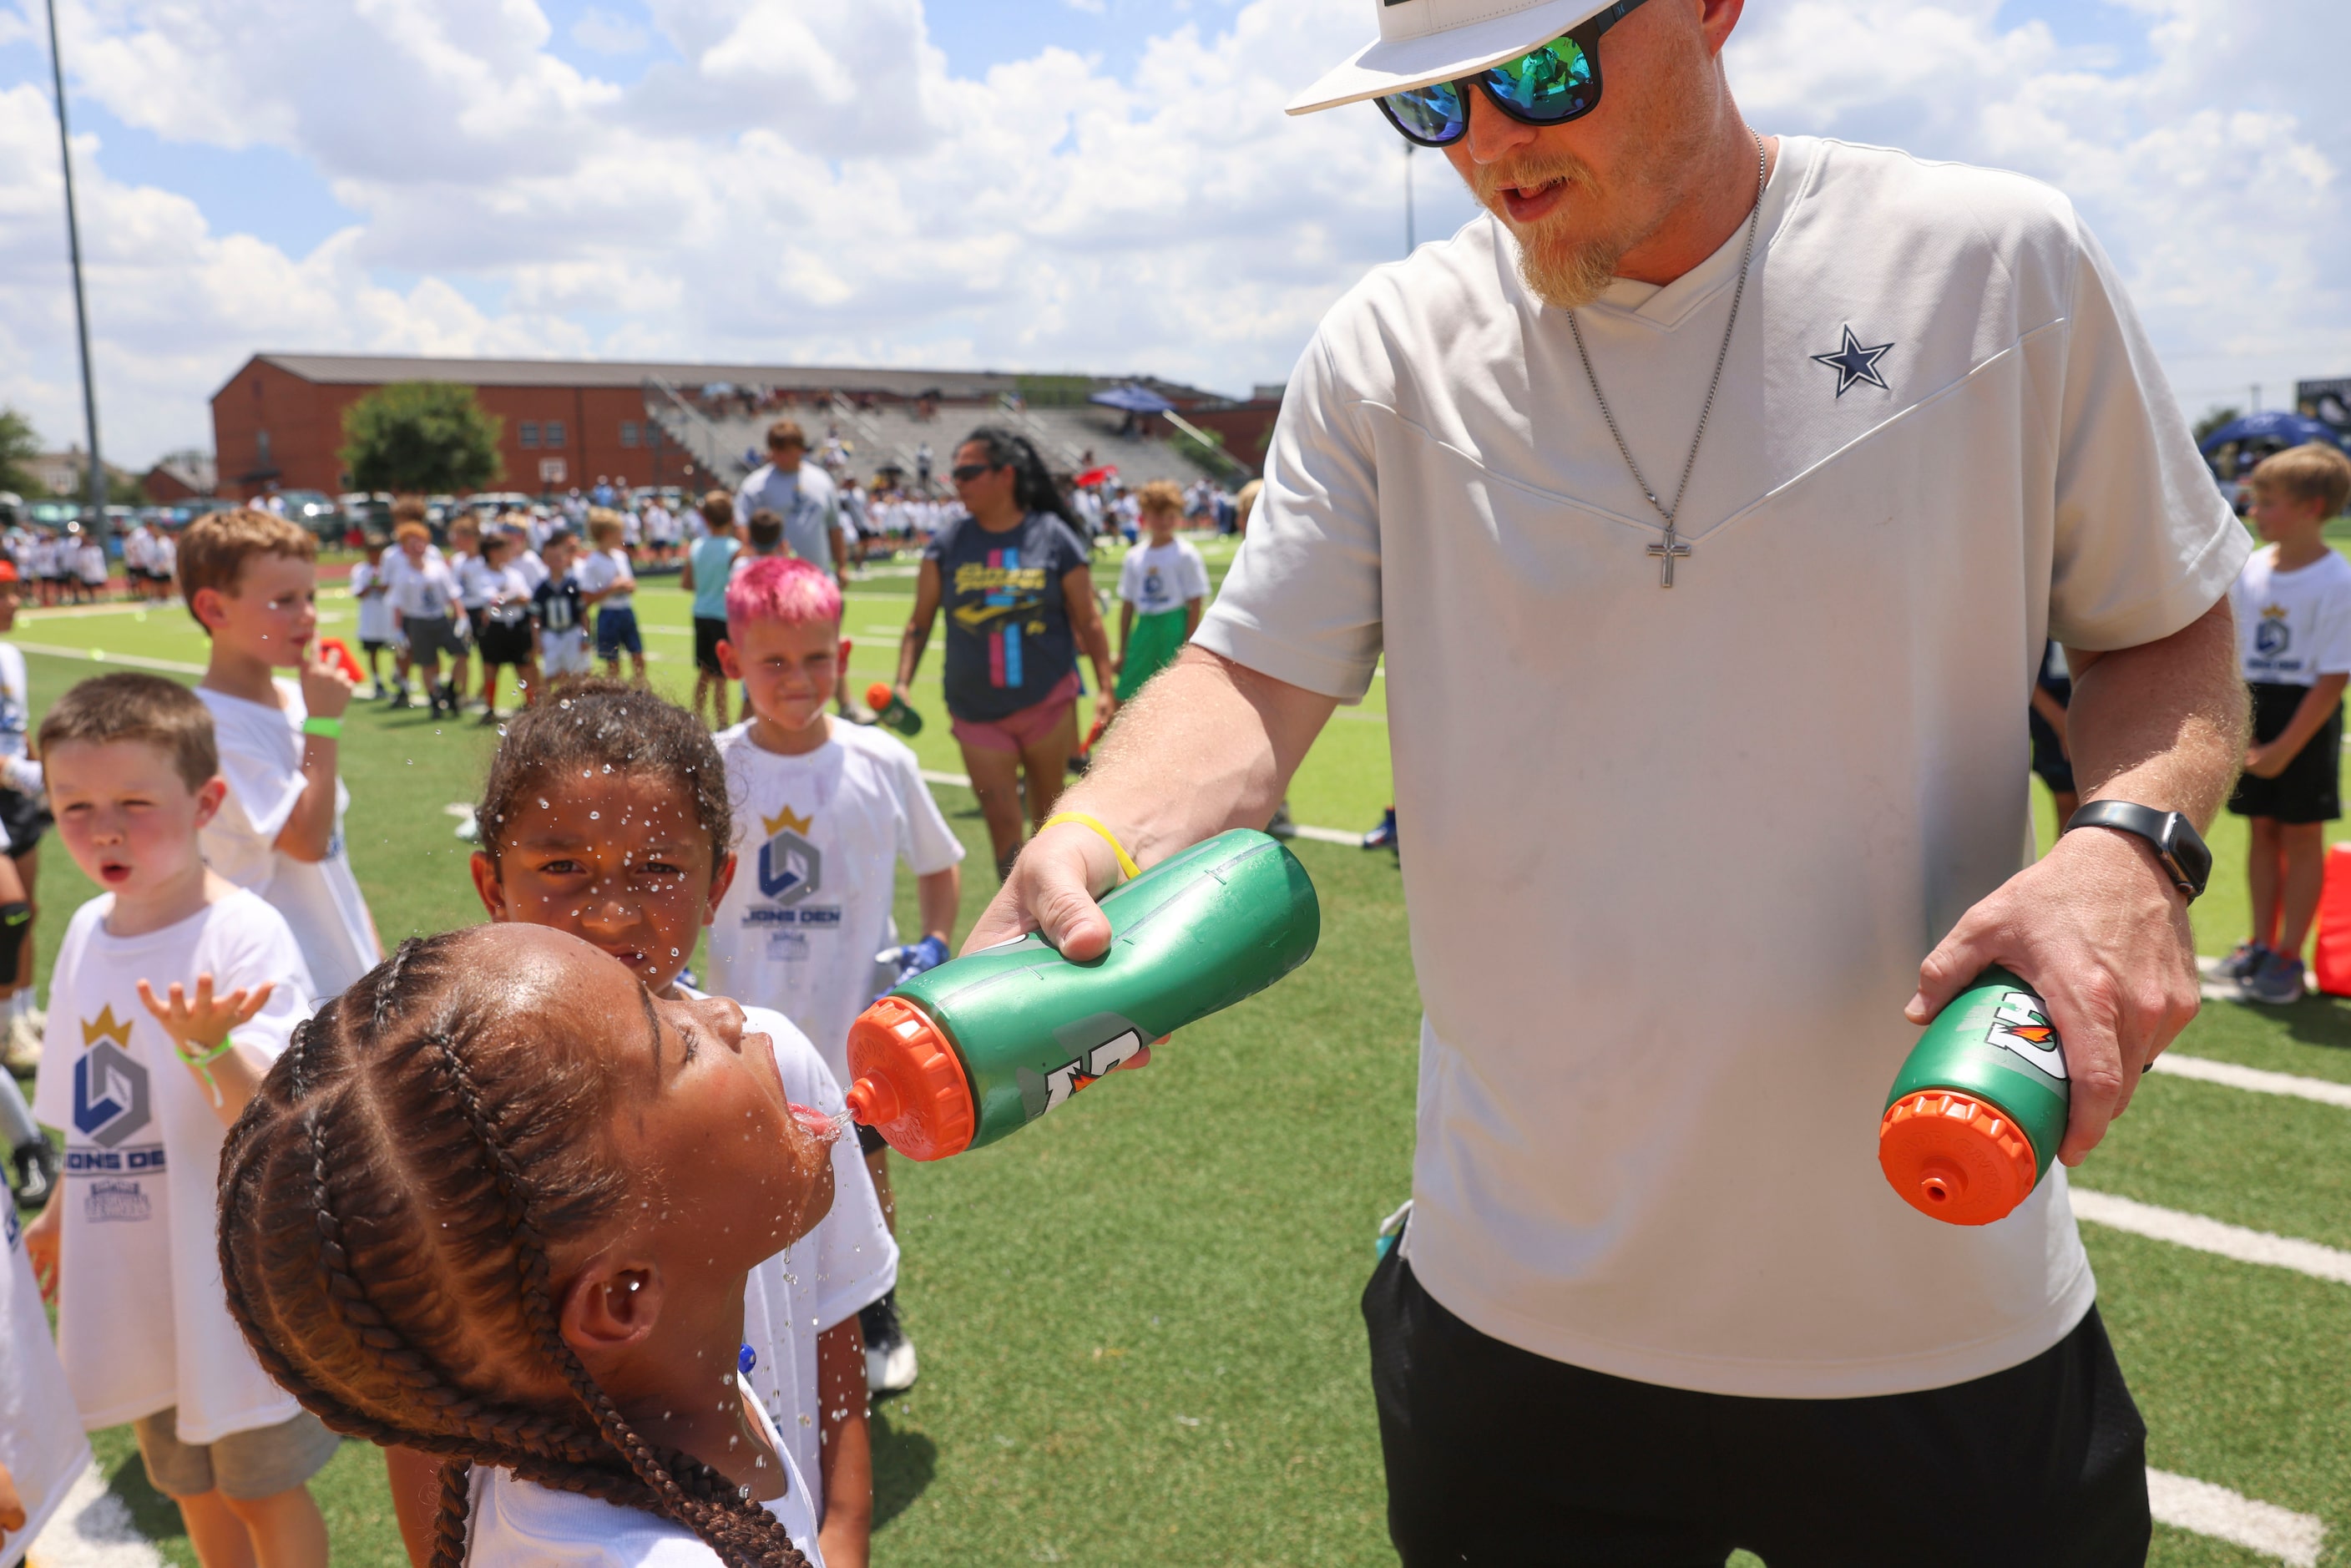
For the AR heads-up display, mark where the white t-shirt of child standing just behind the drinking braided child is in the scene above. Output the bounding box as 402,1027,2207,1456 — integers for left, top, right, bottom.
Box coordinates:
700,988,898,1519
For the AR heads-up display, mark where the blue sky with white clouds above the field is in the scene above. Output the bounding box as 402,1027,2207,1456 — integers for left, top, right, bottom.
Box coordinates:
0,0,2351,461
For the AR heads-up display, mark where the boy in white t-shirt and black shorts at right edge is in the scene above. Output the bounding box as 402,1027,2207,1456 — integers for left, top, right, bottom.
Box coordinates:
2229,444,2351,1004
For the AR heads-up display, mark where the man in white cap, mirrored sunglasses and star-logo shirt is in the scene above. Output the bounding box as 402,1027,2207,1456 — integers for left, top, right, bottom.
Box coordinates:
968,0,2245,1568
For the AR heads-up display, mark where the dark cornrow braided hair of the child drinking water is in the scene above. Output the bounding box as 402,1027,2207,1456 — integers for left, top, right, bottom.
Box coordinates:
219,933,806,1568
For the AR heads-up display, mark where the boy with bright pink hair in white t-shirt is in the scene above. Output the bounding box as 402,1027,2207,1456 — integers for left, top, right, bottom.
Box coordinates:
708,554,964,1394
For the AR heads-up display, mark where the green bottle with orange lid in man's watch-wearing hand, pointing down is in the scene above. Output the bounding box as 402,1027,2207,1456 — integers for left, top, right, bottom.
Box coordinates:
1878,969,2071,1225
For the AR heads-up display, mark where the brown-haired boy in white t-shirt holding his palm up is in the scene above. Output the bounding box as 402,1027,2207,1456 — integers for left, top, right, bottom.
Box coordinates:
26,672,336,1568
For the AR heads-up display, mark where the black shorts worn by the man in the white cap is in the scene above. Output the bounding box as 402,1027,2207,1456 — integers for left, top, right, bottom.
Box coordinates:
1363,1253,2153,1568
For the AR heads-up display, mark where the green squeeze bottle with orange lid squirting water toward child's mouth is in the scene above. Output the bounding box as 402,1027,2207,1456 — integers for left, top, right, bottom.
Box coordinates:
849,827,1322,1159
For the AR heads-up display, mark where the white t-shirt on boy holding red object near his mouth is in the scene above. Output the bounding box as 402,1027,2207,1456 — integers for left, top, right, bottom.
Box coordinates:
195,680,383,1001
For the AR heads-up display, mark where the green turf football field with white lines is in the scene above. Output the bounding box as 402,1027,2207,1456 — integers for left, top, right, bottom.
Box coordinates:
17,535,2351,1568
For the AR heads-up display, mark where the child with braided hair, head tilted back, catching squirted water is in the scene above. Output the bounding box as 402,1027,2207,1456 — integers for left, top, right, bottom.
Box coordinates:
221,924,832,1568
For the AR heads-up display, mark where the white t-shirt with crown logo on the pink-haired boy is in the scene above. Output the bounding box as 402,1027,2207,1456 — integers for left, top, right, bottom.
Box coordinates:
708,720,964,1079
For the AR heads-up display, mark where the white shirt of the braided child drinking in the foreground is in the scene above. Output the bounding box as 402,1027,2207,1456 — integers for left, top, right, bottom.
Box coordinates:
466,1401,825,1568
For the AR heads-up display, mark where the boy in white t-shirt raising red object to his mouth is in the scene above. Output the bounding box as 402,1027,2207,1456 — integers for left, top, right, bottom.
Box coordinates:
181,510,383,999
